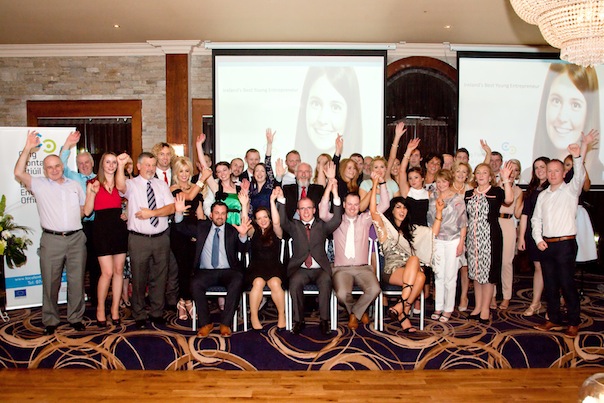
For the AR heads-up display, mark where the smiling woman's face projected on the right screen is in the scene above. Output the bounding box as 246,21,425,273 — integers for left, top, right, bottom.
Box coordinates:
545,74,587,149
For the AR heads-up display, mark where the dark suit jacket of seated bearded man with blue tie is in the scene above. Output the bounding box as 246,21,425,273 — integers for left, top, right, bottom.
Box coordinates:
175,220,247,270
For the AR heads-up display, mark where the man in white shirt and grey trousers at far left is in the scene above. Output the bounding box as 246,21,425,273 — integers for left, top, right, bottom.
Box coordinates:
14,130,86,335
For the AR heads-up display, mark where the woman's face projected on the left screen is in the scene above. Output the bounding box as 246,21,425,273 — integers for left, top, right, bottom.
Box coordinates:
306,76,348,150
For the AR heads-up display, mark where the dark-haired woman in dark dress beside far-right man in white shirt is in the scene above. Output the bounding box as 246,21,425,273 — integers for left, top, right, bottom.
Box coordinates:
518,157,549,316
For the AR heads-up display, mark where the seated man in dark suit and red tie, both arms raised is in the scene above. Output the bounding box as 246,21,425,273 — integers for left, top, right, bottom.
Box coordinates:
277,182,342,335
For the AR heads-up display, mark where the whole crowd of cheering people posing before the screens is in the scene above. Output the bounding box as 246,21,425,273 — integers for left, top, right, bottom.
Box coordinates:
15,118,597,337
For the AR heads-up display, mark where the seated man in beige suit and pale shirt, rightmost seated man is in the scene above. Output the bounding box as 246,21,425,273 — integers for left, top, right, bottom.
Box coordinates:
319,179,389,330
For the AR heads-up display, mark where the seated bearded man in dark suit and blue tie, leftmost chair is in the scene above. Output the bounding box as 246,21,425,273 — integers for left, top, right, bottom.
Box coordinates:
175,194,251,337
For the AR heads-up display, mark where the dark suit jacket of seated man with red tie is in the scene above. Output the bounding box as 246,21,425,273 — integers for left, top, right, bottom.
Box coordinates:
277,203,342,276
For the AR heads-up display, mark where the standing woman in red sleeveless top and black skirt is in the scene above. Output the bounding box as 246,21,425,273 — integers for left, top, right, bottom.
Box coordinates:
84,153,128,327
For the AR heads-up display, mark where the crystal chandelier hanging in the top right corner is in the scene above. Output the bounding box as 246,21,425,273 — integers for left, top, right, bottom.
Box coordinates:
510,0,604,67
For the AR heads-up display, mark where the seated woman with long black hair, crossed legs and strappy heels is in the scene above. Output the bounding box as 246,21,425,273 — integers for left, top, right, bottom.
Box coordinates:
369,175,445,333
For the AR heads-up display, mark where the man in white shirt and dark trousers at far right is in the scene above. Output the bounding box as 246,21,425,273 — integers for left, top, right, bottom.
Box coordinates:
531,130,597,338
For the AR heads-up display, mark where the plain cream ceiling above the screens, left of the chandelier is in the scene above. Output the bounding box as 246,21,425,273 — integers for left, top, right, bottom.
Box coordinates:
0,0,546,45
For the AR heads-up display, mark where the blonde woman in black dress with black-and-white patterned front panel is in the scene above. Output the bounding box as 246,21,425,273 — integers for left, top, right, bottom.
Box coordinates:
465,163,514,324
